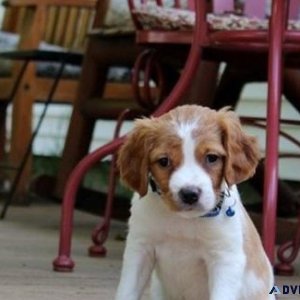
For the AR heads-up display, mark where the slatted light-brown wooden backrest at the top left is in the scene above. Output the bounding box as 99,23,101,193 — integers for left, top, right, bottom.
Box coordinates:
2,0,99,50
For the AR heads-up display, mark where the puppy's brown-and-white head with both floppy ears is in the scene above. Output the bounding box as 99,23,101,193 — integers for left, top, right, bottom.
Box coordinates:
118,105,260,216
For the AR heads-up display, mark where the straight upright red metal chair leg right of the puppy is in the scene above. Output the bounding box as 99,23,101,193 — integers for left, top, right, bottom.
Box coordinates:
262,0,286,264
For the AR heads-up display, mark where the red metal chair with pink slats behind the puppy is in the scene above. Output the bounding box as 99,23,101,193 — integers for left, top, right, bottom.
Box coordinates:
53,0,300,271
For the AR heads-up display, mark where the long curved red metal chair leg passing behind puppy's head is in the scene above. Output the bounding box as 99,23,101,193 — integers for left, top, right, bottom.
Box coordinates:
53,1,206,272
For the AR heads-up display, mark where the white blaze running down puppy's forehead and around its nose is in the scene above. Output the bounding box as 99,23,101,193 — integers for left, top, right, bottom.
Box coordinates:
169,123,216,213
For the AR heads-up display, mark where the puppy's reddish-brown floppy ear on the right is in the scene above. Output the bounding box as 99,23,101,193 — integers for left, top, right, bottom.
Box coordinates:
218,108,261,186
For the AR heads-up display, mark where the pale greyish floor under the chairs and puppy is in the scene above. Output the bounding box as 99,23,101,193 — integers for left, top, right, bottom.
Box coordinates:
0,201,300,300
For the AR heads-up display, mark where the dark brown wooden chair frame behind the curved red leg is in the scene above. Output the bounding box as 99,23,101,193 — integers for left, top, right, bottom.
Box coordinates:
53,31,139,199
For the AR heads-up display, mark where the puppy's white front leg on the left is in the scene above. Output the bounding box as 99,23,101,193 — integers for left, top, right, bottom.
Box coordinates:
116,239,155,300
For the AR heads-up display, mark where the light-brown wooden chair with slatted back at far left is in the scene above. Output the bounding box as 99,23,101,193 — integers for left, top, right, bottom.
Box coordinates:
0,0,103,202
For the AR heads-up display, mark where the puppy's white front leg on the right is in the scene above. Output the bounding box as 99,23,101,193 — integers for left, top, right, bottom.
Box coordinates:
208,253,246,300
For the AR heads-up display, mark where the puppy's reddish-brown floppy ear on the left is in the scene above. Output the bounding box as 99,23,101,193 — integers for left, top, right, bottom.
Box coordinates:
118,119,152,197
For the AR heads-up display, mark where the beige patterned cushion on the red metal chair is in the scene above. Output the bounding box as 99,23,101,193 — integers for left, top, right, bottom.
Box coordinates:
133,5,300,30
